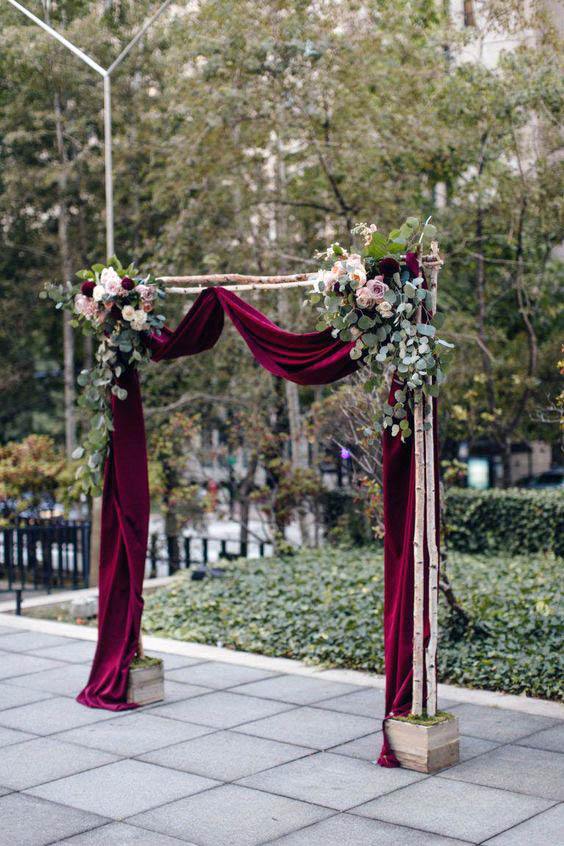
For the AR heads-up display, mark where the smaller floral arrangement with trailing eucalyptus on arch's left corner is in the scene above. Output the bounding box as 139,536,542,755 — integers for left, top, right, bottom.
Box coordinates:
42,258,165,495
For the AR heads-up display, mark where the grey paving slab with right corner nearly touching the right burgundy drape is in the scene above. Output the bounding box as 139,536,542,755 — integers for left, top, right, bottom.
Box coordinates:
238,707,379,749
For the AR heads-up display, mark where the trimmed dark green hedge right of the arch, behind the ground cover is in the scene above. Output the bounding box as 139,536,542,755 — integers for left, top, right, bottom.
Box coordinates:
446,488,564,556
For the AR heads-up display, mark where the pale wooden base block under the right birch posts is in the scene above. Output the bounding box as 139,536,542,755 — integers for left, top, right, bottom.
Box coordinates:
386,714,459,773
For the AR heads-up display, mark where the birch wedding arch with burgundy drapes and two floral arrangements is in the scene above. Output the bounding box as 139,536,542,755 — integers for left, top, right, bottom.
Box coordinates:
47,227,452,767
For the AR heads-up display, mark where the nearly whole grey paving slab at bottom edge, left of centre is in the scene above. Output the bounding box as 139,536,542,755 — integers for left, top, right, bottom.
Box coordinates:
131,784,332,846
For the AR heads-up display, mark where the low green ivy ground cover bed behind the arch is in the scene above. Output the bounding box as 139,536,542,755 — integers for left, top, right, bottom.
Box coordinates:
143,547,562,698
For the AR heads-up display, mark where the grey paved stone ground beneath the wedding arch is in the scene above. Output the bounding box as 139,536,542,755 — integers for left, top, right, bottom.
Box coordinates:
0,627,564,846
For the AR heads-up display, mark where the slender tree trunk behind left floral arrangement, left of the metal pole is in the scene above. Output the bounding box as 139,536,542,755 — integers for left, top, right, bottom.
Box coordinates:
54,94,76,458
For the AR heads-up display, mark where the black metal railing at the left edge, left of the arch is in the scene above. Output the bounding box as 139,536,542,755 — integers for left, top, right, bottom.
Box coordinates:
0,521,90,593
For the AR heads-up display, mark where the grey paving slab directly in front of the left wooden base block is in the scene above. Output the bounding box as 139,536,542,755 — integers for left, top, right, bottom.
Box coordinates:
57,712,211,760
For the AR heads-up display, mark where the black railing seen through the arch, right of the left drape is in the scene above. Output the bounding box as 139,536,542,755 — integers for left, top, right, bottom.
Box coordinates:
145,534,272,578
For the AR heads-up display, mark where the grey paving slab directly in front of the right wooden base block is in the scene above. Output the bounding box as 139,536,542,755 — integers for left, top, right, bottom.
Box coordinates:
353,777,553,843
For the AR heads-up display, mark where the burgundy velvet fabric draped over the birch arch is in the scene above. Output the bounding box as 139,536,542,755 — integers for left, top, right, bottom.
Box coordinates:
78,284,432,766
